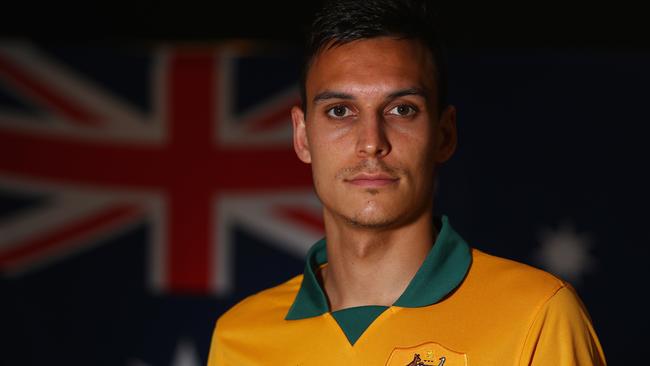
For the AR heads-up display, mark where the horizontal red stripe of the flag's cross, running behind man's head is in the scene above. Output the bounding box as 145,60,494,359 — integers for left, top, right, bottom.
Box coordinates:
0,129,311,190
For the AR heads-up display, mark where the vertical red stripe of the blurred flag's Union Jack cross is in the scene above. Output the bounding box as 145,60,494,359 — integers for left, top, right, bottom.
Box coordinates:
165,51,217,293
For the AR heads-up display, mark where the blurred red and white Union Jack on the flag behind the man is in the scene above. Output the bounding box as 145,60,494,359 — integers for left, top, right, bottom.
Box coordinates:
0,44,322,294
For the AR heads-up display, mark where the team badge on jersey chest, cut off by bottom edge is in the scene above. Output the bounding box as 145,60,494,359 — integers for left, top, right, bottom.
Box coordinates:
386,342,468,366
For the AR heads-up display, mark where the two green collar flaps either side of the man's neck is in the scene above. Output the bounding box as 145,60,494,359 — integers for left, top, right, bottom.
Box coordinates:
285,215,472,320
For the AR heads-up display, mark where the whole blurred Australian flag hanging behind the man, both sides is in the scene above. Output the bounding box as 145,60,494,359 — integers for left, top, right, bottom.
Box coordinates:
0,42,650,366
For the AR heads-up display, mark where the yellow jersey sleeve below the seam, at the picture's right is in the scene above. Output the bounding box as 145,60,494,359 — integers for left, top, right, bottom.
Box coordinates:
520,285,606,366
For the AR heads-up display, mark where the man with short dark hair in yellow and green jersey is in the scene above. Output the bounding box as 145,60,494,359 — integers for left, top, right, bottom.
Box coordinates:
208,0,605,366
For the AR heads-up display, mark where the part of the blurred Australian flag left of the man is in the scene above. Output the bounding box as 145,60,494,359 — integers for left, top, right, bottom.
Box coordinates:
0,43,322,366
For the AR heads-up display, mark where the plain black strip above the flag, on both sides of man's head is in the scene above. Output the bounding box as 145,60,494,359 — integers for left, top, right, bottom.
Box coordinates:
0,0,650,49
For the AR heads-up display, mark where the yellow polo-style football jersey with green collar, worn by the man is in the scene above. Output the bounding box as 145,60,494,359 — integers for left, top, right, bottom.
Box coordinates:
208,216,606,366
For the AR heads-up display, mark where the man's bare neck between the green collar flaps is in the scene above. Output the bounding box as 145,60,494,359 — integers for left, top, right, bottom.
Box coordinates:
321,211,437,311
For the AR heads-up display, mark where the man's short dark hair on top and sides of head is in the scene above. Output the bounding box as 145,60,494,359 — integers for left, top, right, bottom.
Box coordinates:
300,0,447,113
